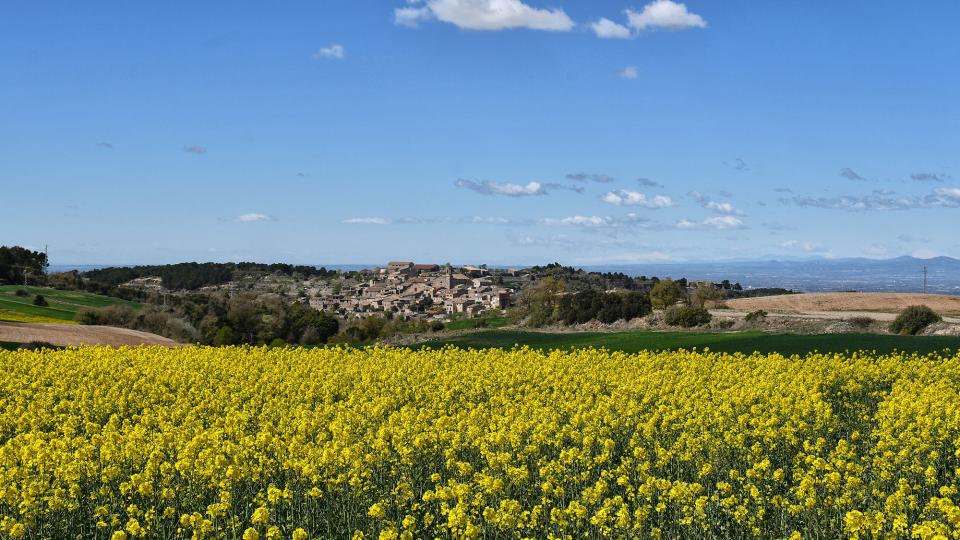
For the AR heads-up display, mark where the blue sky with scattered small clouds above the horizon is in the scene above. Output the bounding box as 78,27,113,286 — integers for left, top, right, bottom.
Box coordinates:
0,0,960,264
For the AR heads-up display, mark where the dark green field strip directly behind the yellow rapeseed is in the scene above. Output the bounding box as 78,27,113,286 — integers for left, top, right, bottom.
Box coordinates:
420,330,960,355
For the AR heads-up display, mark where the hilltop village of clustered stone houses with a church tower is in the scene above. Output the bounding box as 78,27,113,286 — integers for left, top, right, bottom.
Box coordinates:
309,261,535,318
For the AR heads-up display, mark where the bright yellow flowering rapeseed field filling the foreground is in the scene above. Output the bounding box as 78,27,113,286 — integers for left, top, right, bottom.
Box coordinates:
0,347,960,540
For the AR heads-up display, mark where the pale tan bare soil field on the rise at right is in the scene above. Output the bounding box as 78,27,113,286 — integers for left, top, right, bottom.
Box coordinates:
727,293,960,316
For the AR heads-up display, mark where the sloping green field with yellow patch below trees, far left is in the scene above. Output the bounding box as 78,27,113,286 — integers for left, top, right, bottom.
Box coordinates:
0,285,143,322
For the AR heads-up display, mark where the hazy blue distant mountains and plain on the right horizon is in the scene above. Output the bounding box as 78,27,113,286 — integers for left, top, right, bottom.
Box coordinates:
584,257,960,294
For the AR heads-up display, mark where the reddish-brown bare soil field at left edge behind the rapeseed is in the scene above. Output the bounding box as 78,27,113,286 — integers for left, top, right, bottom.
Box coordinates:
0,322,181,347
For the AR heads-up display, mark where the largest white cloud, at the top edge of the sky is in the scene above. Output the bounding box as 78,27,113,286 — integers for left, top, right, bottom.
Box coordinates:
393,0,574,32
